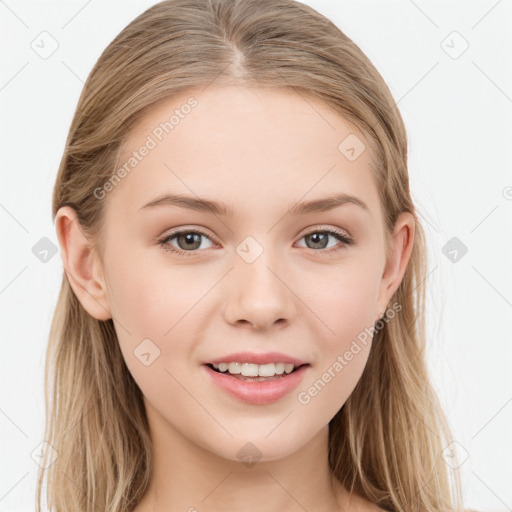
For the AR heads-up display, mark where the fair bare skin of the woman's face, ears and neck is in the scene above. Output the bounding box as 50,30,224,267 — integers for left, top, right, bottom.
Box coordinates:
56,86,414,512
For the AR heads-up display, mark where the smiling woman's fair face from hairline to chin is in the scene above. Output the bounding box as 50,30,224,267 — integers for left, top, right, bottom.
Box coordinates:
70,86,412,460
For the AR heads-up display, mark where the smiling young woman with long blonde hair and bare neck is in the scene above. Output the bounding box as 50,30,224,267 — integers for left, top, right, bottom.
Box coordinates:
37,0,463,512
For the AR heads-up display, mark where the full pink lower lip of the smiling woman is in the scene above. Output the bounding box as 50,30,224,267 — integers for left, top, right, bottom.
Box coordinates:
202,365,309,405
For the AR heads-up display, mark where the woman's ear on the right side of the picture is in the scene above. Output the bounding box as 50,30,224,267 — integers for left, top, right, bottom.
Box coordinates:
375,212,415,321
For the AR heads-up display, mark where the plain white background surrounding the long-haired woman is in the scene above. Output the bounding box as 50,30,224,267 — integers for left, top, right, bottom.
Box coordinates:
0,0,512,512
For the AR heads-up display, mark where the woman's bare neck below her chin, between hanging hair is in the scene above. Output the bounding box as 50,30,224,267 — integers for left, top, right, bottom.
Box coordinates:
134,406,346,512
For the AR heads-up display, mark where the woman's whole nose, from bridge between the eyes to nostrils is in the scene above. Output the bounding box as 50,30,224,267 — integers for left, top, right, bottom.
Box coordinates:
226,236,294,328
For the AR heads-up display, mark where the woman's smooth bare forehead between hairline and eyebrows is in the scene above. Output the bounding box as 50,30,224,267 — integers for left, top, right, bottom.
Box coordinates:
112,86,378,218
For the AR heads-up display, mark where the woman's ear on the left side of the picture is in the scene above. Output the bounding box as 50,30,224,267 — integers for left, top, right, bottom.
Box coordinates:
55,206,112,320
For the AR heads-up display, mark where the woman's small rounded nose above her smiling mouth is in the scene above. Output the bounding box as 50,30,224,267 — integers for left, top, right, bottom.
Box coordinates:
225,247,296,330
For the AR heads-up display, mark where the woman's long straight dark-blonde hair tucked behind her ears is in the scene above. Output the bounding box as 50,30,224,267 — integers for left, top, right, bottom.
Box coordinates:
37,0,462,512
